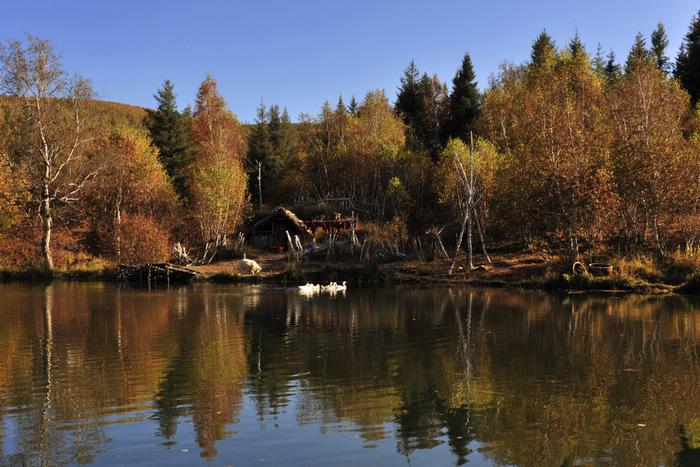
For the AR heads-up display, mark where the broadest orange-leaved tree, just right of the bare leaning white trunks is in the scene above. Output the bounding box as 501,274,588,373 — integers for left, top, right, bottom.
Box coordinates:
482,40,610,261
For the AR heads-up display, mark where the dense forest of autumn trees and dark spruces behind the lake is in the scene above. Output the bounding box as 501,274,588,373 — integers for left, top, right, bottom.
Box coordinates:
0,12,700,269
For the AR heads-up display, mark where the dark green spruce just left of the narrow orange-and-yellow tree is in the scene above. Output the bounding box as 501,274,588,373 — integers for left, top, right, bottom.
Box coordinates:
145,79,193,196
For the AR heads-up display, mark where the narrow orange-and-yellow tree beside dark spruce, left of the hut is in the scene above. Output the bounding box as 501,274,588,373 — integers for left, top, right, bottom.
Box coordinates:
189,75,247,242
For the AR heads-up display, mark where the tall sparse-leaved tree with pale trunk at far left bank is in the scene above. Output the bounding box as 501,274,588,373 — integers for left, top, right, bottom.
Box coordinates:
0,34,96,270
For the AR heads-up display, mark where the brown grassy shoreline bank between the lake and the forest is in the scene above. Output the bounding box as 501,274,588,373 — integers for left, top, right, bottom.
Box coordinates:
0,252,698,295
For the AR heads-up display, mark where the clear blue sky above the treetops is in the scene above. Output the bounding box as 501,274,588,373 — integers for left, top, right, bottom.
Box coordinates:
0,0,700,123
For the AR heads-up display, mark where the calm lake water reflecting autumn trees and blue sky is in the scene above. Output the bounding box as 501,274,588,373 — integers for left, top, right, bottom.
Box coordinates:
0,283,700,466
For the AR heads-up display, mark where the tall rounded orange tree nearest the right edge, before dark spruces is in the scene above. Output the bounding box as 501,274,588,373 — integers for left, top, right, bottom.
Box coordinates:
607,58,697,258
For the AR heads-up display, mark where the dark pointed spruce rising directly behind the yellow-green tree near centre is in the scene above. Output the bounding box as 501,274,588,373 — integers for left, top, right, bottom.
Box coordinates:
447,53,481,141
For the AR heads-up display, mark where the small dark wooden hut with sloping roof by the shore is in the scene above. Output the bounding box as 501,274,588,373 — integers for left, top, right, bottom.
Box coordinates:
246,207,312,251
